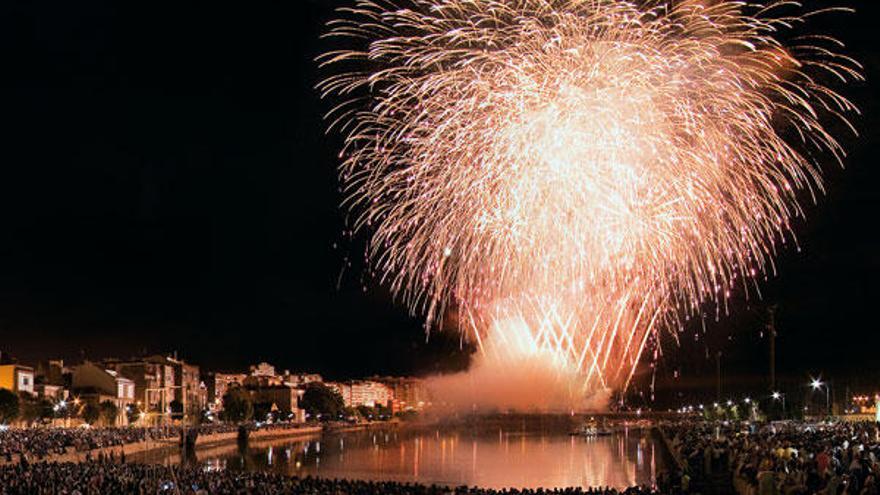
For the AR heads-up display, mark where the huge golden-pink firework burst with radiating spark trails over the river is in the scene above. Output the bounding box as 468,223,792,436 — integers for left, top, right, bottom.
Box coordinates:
319,0,861,402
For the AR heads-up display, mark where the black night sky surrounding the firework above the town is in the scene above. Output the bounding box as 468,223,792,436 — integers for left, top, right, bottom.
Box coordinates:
0,0,880,398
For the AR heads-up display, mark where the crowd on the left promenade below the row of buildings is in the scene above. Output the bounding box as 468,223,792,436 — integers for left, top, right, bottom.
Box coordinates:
0,423,302,463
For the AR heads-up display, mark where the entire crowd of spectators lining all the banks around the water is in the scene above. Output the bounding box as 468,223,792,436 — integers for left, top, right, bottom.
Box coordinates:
8,421,880,495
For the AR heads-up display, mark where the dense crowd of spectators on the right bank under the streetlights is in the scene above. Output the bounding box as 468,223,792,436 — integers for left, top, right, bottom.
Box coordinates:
664,422,880,495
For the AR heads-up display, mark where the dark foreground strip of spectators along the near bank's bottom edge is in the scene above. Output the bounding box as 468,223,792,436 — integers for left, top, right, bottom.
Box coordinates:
0,458,659,495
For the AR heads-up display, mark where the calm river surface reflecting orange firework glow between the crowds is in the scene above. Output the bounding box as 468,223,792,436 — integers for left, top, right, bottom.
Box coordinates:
160,430,662,488
